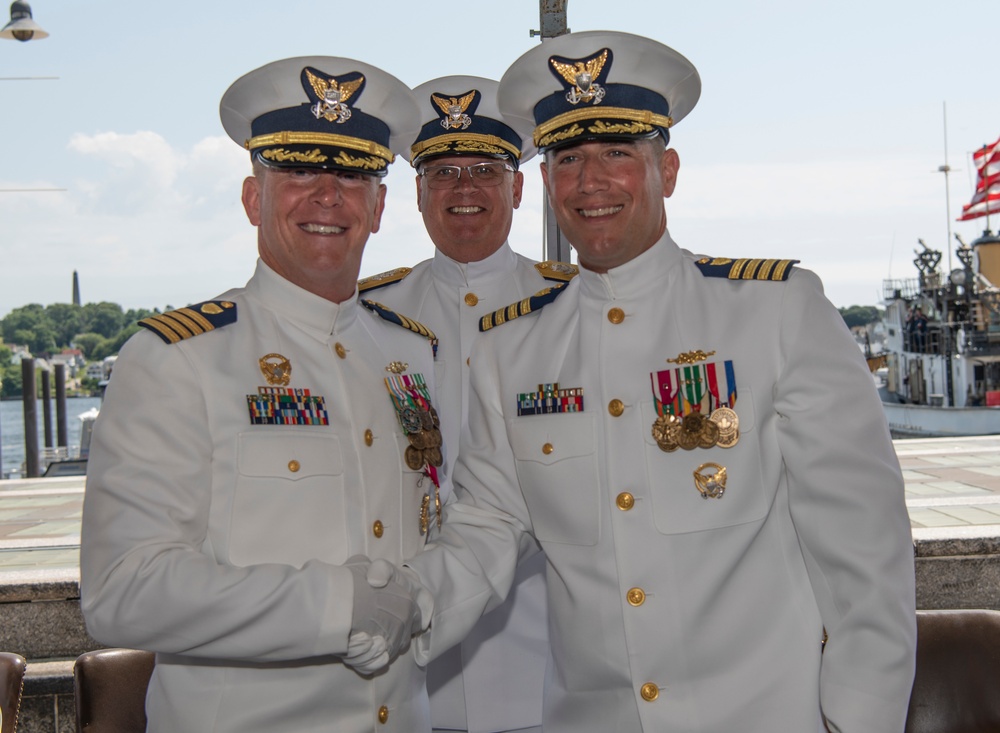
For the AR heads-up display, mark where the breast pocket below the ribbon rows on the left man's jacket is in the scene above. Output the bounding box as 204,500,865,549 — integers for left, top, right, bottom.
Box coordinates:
229,428,349,567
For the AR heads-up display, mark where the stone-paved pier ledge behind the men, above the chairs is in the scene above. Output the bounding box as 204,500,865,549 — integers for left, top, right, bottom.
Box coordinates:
0,436,1000,733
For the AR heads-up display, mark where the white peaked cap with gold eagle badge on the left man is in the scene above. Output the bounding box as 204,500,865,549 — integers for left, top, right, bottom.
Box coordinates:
219,56,420,176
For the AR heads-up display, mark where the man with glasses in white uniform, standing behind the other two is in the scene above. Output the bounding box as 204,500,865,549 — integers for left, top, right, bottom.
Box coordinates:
360,76,575,733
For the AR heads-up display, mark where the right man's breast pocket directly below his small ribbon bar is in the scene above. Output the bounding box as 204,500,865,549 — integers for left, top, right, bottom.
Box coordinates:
507,413,601,545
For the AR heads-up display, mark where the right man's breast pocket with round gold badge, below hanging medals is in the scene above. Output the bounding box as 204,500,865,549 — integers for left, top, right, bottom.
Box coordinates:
642,388,769,534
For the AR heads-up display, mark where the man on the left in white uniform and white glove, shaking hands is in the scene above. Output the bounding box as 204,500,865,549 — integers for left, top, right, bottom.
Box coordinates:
81,57,442,733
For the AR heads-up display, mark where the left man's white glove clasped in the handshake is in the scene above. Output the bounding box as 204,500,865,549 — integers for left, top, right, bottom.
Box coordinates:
345,556,426,661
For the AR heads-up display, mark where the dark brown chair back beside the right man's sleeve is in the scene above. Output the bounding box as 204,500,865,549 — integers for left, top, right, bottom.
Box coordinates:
906,610,1000,733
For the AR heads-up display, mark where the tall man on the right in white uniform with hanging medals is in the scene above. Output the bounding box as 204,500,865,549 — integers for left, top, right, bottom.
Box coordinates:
382,32,916,733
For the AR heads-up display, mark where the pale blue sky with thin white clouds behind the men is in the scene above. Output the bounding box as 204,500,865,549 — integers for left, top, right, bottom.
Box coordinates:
0,0,1000,317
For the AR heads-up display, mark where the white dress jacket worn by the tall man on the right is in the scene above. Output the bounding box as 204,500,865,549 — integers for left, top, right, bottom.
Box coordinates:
409,234,916,733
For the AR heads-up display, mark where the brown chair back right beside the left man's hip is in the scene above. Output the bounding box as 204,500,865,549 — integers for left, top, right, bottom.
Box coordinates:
73,649,156,733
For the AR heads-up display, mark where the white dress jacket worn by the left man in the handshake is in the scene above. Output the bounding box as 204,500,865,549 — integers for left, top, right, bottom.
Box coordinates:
81,262,433,733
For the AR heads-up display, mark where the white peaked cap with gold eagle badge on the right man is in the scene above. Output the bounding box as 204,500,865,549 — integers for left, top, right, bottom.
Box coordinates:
497,31,701,152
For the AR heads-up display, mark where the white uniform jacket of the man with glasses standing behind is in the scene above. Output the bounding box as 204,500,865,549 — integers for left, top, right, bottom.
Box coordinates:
372,243,551,733
